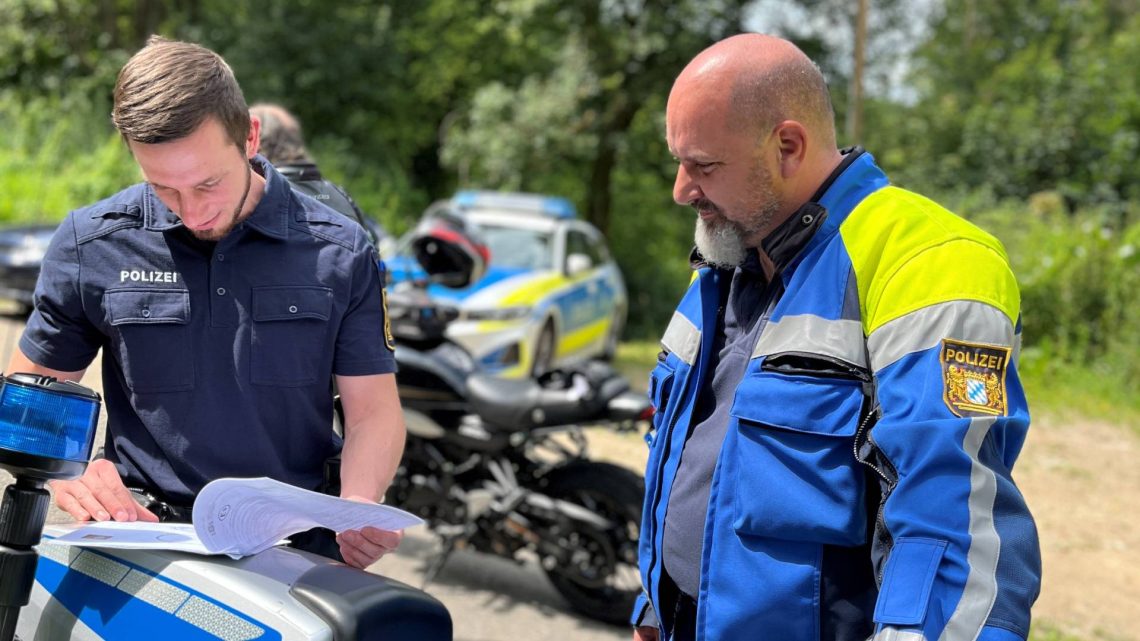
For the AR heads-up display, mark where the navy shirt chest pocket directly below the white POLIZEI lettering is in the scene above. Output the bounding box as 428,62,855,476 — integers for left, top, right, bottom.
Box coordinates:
103,290,194,393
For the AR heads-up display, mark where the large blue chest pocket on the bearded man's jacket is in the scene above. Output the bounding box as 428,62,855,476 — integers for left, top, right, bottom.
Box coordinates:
732,357,866,545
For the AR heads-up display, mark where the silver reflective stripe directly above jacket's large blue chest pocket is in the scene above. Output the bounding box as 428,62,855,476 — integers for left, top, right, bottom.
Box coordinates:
752,314,866,367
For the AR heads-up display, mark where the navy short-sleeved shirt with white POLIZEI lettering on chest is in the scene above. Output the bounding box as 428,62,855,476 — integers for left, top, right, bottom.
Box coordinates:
19,156,396,504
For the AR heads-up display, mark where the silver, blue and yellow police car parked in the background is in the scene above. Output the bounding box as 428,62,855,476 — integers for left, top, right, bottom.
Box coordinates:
385,190,628,378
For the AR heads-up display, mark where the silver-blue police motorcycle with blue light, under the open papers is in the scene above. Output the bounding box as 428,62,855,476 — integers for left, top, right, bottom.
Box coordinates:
0,373,451,641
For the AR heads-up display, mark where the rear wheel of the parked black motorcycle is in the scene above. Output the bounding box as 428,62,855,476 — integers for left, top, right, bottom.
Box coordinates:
544,461,645,625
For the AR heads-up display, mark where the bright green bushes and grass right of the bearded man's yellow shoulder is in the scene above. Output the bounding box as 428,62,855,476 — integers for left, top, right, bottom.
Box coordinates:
959,196,1140,420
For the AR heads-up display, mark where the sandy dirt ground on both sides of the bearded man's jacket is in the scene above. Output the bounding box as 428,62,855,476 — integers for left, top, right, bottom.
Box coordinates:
589,408,1140,641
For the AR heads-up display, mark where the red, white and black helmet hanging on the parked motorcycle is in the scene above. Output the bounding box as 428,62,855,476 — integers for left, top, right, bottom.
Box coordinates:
410,203,491,289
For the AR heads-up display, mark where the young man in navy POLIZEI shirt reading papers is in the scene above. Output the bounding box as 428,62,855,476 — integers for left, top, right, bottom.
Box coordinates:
8,38,404,568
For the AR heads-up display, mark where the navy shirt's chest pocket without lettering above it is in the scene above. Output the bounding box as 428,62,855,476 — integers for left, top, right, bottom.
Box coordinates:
250,286,332,387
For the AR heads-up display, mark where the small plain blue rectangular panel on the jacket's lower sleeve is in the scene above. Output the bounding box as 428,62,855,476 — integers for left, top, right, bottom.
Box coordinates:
874,536,946,625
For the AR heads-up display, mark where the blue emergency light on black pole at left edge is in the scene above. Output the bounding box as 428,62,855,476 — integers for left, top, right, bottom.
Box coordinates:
0,374,100,641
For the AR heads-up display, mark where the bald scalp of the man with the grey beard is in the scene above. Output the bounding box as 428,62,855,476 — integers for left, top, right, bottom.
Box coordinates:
670,33,836,149
